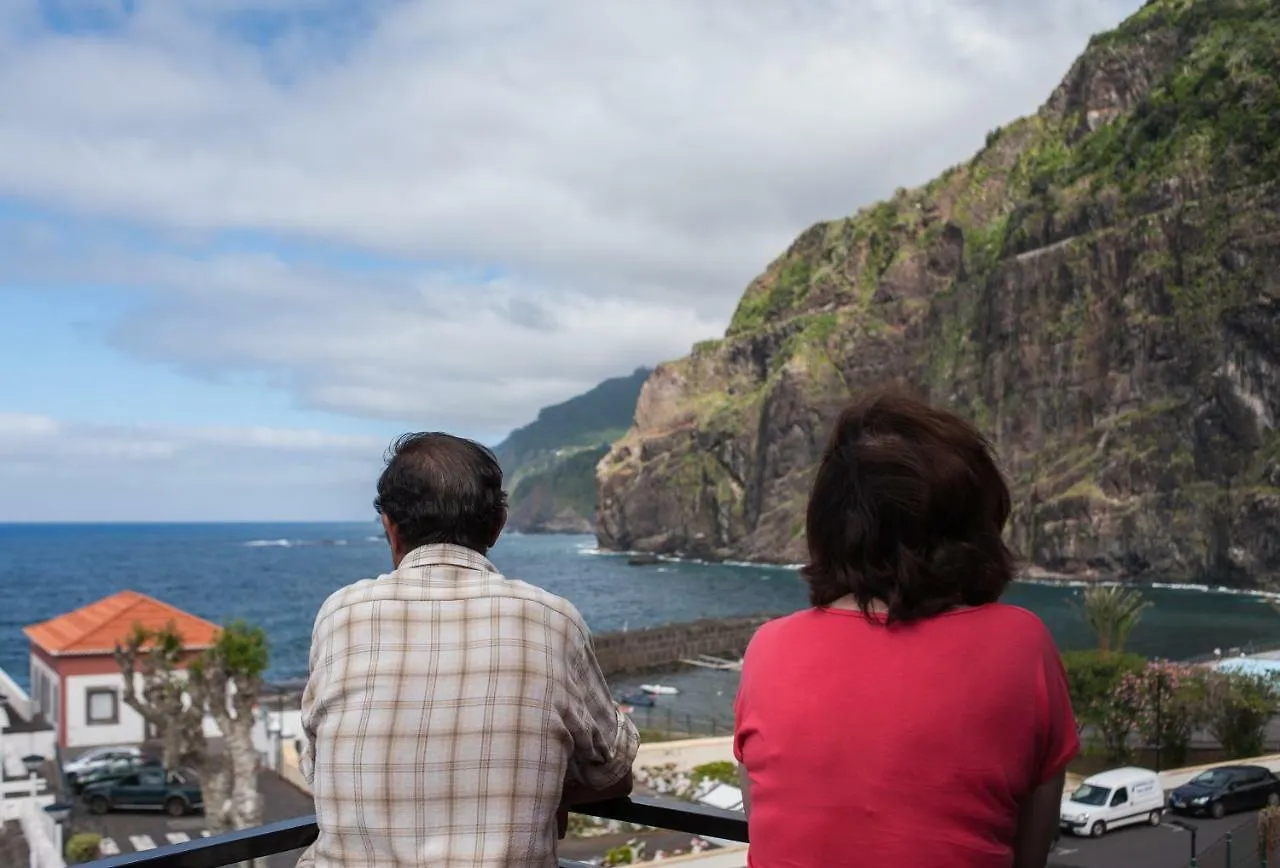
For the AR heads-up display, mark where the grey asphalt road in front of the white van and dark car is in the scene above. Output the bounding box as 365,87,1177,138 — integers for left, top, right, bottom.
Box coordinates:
1050,812,1254,868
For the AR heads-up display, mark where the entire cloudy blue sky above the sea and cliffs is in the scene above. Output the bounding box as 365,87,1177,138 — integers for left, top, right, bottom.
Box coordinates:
0,0,1140,521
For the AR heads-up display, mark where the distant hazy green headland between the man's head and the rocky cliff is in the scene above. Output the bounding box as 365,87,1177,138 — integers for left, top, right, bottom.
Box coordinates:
494,367,650,533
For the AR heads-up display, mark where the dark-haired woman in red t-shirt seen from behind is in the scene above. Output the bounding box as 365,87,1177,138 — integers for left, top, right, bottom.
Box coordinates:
733,394,1079,868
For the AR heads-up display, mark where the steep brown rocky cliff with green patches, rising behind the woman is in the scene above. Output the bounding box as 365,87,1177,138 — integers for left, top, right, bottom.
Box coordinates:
596,0,1280,585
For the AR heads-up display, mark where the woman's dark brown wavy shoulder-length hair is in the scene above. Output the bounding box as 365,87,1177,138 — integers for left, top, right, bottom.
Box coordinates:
801,392,1014,623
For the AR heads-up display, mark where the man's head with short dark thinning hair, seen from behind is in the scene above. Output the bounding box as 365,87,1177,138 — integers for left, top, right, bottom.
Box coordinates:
374,431,507,566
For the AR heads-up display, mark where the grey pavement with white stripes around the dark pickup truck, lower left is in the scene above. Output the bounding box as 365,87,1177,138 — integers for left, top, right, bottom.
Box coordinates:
68,772,315,868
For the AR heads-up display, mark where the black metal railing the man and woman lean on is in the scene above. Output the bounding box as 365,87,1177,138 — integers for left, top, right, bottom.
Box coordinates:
86,796,746,868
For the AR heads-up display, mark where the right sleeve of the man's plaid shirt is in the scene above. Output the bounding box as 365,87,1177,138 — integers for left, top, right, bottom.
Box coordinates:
566,625,640,790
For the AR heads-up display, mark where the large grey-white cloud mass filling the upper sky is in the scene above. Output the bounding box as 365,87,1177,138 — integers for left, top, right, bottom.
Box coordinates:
0,0,1138,433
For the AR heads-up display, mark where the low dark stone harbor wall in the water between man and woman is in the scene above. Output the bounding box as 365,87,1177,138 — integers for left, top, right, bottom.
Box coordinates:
593,615,778,676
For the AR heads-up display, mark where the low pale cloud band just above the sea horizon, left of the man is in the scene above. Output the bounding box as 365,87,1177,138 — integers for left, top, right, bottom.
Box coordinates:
0,414,388,522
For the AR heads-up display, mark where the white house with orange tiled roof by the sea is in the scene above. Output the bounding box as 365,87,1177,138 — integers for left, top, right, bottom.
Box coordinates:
23,590,218,748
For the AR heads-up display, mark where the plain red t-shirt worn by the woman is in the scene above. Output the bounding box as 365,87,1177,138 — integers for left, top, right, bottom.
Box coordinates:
733,603,1080,868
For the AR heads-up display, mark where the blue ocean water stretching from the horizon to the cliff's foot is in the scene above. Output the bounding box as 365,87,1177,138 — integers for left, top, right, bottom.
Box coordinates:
0,521,1280,714
